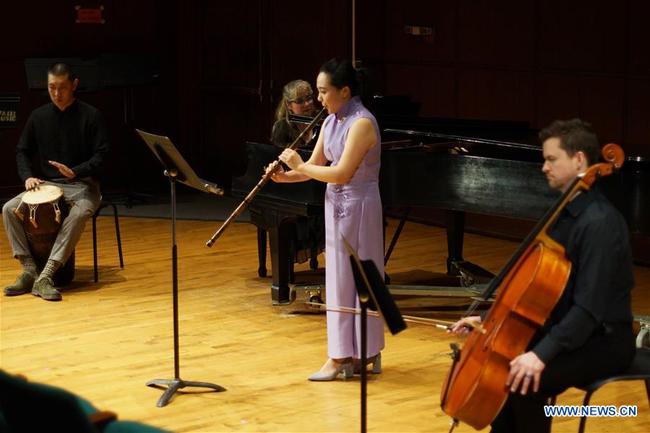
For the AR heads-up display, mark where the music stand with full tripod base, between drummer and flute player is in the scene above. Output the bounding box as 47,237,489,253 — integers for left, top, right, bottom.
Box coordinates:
136,129,226,407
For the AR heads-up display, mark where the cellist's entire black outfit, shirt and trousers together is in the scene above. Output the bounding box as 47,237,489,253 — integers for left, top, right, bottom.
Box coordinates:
492,189,635,433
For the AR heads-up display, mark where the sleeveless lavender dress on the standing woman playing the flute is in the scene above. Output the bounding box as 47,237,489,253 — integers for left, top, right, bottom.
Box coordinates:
323,97,384,358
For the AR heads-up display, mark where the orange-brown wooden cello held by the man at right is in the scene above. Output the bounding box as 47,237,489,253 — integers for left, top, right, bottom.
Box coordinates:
440,143,625,430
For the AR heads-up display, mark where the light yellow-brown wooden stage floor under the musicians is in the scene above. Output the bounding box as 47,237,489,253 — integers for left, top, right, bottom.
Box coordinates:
0,217,650,433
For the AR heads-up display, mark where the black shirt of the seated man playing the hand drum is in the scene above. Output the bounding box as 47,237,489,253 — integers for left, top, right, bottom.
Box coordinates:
16,100,109,182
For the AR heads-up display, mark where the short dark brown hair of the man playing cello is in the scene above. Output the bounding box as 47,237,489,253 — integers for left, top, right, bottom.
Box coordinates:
539,119,600,165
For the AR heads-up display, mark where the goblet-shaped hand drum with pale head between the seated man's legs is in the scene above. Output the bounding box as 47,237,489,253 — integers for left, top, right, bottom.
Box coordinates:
14,185,74,286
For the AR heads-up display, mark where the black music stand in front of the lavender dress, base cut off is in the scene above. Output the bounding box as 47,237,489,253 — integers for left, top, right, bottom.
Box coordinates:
343,238,406,433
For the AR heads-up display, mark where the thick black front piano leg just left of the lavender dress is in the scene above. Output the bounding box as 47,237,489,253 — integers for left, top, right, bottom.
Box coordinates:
269,223,293,305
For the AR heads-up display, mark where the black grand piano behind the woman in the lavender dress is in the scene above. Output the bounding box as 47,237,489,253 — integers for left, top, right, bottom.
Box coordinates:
232,117,650,304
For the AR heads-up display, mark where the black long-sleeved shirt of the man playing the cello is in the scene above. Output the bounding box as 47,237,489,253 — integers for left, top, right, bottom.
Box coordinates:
532,189,634,363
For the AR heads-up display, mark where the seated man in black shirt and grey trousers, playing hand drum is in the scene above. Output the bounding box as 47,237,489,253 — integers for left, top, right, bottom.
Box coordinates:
2,63,109,301
